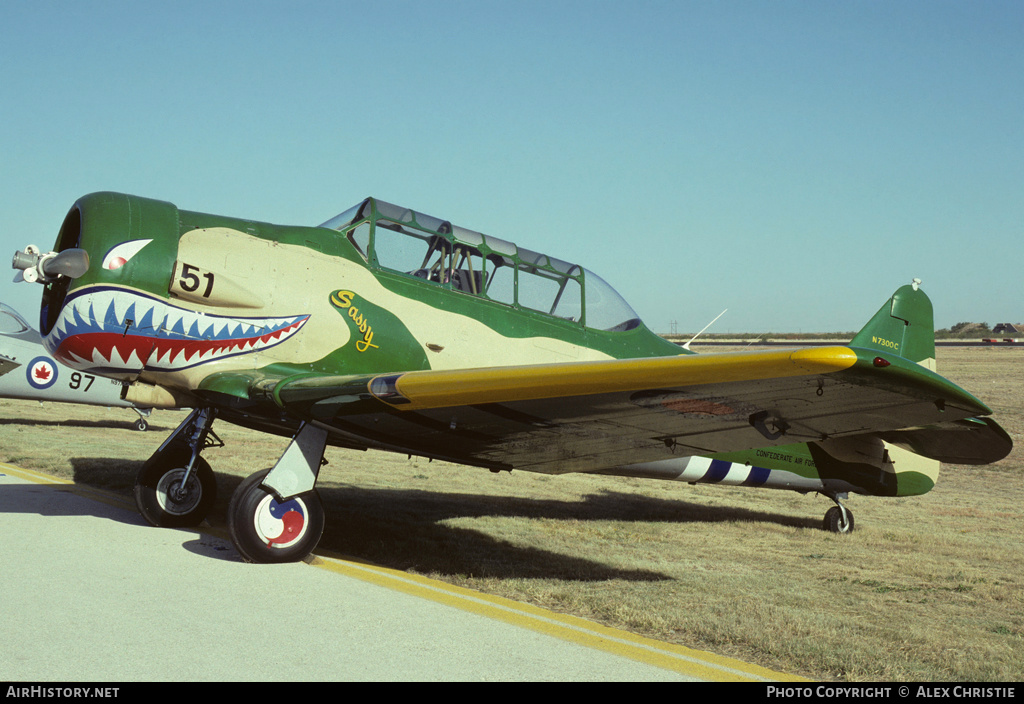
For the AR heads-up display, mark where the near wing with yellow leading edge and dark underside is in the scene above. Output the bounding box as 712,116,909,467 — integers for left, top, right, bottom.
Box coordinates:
195,347,1003,474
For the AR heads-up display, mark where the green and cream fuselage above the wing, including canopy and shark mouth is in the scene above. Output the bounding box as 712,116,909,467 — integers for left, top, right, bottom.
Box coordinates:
41,193,681,393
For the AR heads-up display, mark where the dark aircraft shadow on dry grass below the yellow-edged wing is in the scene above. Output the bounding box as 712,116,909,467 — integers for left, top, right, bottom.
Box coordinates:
311,486,816,581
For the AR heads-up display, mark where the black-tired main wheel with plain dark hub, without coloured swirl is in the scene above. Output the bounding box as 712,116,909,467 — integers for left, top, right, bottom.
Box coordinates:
135,446,217,528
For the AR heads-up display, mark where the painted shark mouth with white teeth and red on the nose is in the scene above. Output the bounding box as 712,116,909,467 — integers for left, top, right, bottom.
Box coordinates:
46,289,309,371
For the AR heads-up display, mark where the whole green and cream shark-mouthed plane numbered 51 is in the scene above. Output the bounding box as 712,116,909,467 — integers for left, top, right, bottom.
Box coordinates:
13,192,1012,562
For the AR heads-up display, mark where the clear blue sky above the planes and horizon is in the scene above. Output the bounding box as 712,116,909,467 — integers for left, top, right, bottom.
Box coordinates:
0,0,1024,332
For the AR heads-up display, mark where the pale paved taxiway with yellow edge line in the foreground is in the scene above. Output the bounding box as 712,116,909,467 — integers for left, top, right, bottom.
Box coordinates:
0,463,795,681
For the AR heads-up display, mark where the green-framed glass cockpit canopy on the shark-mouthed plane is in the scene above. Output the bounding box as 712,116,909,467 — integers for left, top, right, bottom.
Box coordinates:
321,199,640,331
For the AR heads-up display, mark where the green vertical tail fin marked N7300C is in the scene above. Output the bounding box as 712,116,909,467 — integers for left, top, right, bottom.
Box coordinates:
850,278,935,371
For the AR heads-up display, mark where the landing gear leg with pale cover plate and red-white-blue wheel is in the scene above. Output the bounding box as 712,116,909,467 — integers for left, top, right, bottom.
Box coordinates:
227,423,327,563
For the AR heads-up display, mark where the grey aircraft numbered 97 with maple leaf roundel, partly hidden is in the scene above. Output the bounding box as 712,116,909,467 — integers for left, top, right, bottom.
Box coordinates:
0,303,153,430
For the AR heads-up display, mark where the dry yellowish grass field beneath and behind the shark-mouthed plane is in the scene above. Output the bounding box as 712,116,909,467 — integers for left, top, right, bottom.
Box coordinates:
0,348,1024,681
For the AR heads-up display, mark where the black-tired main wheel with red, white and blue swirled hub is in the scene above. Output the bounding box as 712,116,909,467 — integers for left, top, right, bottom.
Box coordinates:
227,470,324,563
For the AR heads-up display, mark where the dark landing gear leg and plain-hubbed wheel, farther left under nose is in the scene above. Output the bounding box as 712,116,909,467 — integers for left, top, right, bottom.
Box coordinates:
135,408,223,528
